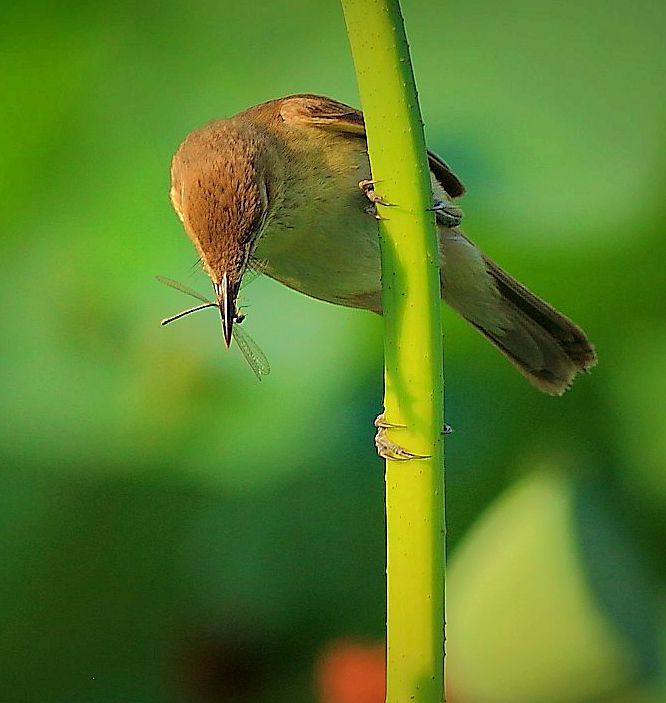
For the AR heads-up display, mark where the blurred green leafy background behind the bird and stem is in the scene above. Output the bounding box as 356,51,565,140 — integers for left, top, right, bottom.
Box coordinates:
0,0,666,703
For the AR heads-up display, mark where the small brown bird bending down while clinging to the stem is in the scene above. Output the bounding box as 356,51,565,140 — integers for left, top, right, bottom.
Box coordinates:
171,95,597,395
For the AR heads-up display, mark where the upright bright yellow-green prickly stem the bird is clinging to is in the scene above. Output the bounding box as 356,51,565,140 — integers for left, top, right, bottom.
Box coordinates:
341,0,445,703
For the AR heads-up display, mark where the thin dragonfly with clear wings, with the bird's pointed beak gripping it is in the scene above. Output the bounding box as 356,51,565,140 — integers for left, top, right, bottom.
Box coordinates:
157,274,271,381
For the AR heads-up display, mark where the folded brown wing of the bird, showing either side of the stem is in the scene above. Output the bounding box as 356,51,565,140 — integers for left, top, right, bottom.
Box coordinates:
280,94,465,198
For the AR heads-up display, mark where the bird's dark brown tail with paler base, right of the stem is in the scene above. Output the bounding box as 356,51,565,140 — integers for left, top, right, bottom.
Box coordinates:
440,229,597,395
